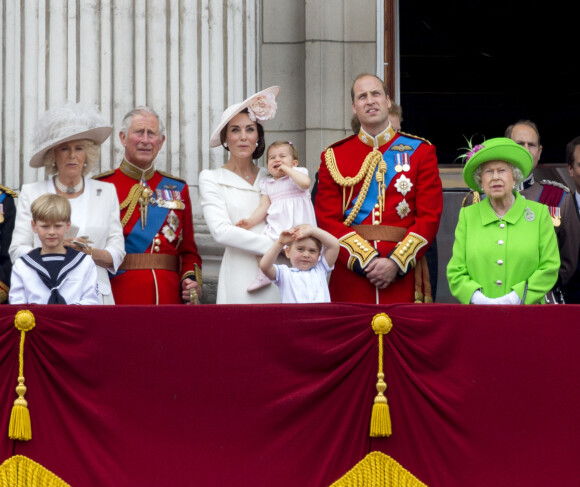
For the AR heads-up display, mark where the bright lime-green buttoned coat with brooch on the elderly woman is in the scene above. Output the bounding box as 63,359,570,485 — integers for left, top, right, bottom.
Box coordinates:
447,193,560,304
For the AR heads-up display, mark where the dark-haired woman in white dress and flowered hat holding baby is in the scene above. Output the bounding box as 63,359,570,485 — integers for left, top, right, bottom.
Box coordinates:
199,86,280,304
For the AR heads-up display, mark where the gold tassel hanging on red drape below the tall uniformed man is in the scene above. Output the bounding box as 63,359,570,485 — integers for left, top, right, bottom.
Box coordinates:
370,313,393,437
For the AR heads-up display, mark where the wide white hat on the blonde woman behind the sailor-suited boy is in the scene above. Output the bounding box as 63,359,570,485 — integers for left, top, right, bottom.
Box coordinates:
29,103,113,167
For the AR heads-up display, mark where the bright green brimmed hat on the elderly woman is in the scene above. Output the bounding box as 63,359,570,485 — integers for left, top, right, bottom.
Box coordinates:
463,137,534,191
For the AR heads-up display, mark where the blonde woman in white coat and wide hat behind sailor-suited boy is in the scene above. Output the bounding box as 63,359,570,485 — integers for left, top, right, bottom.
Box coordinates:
10,103,125,304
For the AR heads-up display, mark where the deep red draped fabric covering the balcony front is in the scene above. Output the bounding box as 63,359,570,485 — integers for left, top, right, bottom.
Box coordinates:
0,304,580,487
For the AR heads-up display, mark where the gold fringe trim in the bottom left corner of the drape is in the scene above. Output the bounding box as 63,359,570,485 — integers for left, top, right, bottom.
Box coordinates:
0,455,71,487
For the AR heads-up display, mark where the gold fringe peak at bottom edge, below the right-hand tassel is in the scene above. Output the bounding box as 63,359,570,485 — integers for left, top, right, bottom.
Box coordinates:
330,451,427,487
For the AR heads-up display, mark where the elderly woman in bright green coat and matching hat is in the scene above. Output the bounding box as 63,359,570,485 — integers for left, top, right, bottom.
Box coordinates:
447,137,560,304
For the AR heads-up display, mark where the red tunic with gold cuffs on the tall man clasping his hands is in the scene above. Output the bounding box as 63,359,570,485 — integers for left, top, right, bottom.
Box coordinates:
314,126,443,303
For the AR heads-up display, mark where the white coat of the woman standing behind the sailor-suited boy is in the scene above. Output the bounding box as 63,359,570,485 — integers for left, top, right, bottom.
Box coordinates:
10,177,125,304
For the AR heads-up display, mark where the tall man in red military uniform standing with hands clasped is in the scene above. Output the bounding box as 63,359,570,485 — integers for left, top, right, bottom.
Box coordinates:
314,74,443,304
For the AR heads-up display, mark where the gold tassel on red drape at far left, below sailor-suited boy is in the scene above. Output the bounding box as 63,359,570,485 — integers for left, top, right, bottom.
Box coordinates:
8,310,36,441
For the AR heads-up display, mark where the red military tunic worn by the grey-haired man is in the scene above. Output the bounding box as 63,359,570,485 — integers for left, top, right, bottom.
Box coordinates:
96,161,201,304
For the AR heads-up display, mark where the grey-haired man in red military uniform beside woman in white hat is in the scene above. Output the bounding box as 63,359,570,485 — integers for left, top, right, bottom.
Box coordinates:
96,107,201,304
